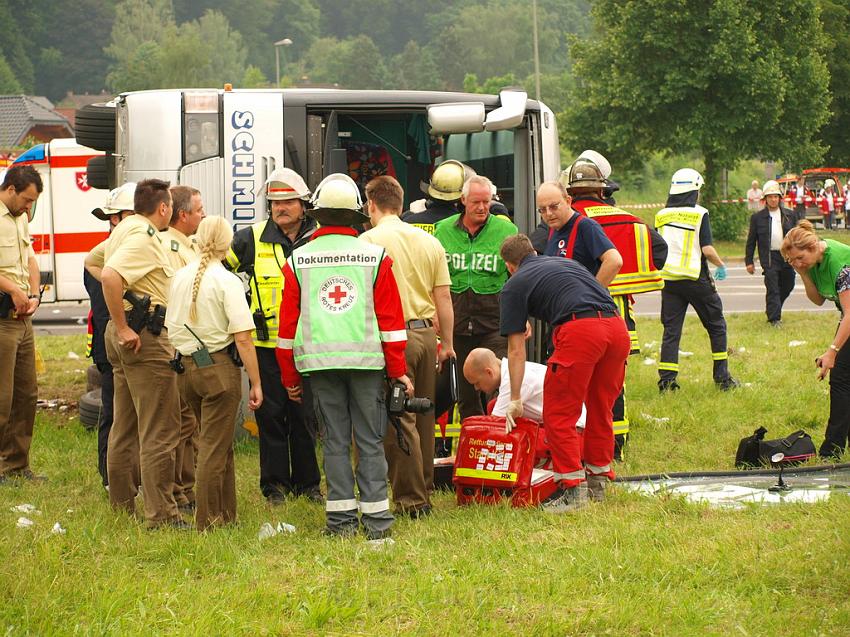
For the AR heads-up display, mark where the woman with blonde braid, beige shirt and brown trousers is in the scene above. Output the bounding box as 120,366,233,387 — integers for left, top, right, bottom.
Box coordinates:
165,217,263,531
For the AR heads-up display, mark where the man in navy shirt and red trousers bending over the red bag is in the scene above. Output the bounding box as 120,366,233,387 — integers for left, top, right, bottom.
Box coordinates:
500,234,630,513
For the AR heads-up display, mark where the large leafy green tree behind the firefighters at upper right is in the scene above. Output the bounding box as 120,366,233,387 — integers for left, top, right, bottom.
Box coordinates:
562,0,829,195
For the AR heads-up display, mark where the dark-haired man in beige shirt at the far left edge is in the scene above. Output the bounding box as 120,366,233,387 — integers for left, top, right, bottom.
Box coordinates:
0,166,44,483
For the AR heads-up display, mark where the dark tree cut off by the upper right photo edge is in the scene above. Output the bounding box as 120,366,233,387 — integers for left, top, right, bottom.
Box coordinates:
820,0,850,166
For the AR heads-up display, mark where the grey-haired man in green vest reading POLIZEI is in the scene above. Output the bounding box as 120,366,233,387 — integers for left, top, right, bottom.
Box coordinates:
434,175,517,419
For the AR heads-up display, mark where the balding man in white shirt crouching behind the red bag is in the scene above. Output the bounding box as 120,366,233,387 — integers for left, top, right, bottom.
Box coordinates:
463,347,587,429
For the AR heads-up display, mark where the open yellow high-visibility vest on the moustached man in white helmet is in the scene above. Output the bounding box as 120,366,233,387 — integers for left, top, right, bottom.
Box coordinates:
248,221,286,347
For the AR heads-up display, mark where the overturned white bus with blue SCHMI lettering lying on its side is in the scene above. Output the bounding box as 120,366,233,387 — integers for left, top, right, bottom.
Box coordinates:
76,85,560,232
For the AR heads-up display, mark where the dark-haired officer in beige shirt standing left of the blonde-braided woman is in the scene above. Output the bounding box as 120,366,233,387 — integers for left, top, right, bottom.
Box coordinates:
102,179,187,530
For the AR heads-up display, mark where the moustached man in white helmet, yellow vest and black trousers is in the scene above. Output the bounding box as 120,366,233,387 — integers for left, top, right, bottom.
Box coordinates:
225,168,322,504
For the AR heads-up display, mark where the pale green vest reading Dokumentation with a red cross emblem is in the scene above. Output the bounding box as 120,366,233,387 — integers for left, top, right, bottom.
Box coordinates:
290,234,388,374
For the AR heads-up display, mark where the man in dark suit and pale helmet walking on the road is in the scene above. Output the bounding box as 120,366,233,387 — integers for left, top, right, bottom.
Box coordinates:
744,180,796,327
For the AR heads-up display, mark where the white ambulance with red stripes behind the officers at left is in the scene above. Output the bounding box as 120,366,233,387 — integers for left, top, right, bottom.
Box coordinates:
13,139,108,303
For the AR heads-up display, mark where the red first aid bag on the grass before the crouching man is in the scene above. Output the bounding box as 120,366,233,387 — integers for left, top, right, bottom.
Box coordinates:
453,416,556,506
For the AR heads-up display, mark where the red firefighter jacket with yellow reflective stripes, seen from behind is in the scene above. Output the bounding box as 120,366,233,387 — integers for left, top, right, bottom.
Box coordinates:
572,199,664,295
